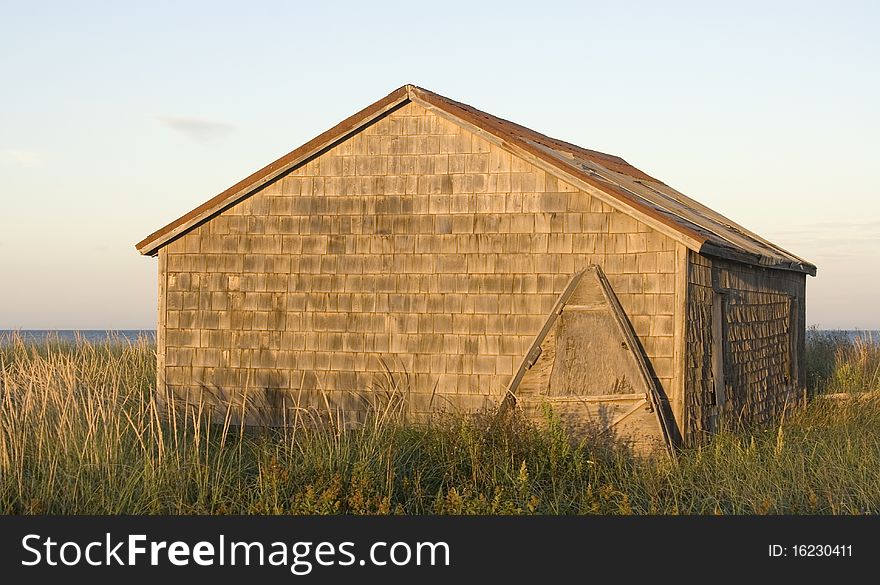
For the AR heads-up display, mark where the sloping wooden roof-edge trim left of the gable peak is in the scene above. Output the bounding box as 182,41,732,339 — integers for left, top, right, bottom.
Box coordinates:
135,86,409,256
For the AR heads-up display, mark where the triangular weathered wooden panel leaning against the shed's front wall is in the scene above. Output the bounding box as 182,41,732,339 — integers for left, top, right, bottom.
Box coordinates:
509,266,670,451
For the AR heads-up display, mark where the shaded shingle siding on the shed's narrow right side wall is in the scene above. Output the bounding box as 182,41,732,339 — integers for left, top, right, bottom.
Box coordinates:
685,252,806,444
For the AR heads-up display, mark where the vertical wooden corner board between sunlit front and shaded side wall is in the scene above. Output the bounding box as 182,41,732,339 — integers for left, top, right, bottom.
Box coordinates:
670,244,691,445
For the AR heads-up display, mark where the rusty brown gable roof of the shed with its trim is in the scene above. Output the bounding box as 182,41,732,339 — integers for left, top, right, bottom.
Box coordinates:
135,85,816,276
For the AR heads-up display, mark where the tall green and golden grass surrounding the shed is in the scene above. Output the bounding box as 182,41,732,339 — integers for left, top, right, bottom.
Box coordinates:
0,334,880,514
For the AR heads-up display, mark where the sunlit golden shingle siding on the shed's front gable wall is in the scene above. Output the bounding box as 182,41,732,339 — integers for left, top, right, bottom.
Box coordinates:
156,103,685,416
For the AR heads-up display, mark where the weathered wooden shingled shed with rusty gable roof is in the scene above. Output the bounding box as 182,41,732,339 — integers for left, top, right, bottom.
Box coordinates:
137,85,816,449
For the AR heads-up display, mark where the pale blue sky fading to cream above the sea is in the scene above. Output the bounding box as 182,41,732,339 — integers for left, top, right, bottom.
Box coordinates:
0,0,880,329
